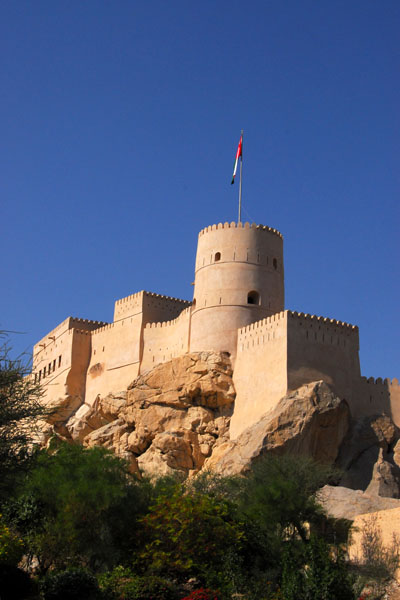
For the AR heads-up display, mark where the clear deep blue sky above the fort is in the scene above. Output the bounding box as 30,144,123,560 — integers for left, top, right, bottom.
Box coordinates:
0,0,400,377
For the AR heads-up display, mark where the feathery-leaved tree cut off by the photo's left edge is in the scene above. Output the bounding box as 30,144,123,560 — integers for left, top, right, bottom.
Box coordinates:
0,334,46,504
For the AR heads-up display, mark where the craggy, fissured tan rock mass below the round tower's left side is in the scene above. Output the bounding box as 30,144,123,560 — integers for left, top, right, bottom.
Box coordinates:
41,352,235,477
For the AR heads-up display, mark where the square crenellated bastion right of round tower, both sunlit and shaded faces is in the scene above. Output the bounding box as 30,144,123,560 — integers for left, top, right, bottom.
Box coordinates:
231,311,360,439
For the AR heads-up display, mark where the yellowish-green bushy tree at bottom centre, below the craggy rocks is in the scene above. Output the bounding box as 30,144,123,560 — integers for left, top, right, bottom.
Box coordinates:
140,484,244,587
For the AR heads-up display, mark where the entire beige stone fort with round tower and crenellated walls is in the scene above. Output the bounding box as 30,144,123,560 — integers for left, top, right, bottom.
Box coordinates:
33,222,400,439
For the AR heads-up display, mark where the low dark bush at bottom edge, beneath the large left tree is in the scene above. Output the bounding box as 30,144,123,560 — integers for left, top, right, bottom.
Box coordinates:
40,569,100,600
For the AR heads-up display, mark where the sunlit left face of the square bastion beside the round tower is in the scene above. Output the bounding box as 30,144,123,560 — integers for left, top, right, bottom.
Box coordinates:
230,312,287,439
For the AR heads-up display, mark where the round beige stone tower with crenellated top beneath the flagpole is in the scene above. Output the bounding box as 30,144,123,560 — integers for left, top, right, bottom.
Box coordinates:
190,223,284,360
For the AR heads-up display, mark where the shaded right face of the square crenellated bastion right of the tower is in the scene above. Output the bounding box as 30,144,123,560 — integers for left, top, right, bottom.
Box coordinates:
287,311,360,407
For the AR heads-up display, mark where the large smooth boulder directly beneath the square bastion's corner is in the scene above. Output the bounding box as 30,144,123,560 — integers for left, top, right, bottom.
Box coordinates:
205,381,350,474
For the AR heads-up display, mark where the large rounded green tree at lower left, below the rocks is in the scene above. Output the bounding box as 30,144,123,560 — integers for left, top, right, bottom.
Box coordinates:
14,444,147,571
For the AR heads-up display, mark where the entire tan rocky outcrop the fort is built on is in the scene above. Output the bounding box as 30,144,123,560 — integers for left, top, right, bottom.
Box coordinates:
38,352,400,506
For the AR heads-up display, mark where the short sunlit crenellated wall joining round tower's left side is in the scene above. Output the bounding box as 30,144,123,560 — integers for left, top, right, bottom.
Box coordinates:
140,307,191,373
